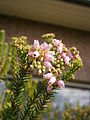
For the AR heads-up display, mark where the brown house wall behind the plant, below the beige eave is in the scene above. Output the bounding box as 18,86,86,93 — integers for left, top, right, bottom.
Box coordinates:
0,15,90,83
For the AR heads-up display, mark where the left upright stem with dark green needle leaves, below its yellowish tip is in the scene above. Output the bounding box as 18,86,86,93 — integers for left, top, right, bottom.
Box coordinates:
3,39,28,120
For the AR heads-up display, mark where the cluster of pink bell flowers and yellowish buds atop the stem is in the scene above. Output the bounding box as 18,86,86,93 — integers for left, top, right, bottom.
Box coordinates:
28,36,79,91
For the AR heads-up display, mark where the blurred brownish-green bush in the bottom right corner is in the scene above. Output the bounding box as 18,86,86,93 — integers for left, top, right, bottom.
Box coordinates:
62,103,90,120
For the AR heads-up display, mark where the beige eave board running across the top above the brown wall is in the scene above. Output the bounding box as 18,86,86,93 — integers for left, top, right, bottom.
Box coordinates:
0,0,90,31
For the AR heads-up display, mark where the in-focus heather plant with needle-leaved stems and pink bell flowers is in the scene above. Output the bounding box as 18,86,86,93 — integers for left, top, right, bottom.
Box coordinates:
2,33,82,120
